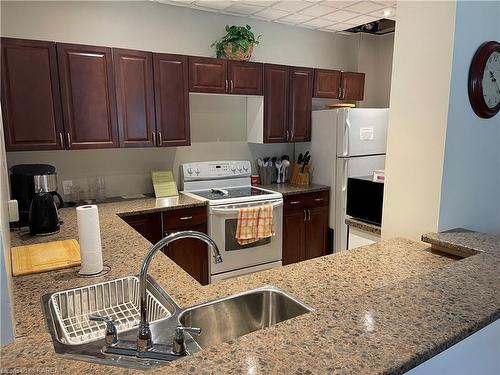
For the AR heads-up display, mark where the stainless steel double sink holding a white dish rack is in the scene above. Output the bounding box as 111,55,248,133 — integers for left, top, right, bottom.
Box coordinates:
42,276,312,369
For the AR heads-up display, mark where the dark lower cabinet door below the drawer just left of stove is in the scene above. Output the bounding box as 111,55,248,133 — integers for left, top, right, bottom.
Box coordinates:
164,224,209,285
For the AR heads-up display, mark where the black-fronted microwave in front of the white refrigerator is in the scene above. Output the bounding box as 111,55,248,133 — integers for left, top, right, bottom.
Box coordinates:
346,176,384,225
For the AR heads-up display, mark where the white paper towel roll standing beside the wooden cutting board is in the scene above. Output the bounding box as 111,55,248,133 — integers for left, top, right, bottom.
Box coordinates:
76,205,103,275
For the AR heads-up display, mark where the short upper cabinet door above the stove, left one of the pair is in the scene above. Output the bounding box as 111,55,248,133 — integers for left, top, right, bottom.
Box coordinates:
189,56,228,94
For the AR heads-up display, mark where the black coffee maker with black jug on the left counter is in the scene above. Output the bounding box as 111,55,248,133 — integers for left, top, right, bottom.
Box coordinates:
10,164,64,235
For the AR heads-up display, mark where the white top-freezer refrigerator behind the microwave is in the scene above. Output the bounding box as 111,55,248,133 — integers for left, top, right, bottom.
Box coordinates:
310,108,389,251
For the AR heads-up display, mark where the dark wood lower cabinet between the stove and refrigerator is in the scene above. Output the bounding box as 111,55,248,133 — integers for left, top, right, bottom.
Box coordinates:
282,191,329,265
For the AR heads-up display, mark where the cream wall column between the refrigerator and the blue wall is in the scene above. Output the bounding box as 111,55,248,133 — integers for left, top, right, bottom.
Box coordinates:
382,1,456,240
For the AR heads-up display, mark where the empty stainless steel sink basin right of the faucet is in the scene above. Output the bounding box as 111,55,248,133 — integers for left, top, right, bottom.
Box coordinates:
179,287,312,349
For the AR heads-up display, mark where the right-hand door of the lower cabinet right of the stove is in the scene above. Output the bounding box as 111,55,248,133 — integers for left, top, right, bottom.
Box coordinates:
306,206,328,259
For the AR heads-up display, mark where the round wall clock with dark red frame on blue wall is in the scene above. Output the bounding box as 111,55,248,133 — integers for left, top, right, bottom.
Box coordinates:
469,41,500,118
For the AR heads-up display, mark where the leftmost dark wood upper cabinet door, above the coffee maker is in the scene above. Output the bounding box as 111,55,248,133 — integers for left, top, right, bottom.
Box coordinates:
1,38,64,151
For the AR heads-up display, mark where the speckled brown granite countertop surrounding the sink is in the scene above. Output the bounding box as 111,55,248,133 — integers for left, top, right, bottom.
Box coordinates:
1,194,500,374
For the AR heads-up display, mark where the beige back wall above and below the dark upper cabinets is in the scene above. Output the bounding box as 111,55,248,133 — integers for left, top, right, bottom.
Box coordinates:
1,1,366,196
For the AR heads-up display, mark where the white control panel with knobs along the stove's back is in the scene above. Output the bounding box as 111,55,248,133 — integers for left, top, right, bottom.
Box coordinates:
181,160,252,181
